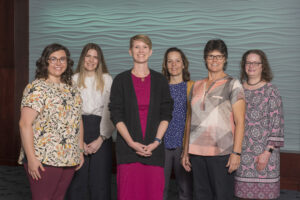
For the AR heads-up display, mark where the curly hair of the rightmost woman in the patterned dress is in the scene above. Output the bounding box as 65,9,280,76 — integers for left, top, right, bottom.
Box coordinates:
240,49,273,82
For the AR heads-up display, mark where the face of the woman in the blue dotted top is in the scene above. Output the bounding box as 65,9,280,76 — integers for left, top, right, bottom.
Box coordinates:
167,51,184,76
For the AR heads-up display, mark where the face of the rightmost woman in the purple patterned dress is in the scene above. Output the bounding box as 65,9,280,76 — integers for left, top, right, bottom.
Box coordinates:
245,53,262,78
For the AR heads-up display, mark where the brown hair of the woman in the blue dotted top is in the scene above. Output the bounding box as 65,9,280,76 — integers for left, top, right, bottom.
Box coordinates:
162,47,190,81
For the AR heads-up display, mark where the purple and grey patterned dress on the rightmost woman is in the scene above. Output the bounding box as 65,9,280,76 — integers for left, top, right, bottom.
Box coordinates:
235,83,284,199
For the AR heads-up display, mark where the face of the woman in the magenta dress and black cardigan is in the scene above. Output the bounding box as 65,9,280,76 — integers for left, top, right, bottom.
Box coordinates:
129,40,152,63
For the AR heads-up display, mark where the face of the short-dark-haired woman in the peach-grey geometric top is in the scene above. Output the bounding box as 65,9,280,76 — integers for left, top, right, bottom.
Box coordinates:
205,50,226,73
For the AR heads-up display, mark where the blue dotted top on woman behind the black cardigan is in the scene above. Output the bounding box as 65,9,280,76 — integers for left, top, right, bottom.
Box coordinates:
164,82,187,149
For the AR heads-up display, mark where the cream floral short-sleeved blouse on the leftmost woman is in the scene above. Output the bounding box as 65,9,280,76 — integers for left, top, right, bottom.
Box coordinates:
19,80,82,167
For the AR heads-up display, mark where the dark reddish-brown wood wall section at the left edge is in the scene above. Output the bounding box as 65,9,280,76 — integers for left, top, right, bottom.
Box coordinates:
0,0,29,165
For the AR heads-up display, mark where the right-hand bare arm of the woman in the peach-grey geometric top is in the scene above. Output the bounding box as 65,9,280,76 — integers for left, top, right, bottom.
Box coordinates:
226,99,246,173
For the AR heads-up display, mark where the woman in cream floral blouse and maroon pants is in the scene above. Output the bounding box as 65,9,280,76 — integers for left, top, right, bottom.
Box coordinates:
19,43,84,200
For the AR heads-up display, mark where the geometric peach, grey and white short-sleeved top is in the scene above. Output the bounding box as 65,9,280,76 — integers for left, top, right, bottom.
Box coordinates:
189,76,244,156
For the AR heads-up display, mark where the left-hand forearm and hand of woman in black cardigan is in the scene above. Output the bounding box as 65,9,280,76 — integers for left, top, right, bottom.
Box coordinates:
116,122,152,156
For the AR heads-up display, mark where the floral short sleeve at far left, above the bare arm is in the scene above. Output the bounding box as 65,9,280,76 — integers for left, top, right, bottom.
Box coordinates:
21,83,45,113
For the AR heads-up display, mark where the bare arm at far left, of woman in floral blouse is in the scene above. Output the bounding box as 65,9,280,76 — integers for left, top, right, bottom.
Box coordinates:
19,107,45,180
